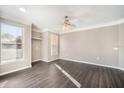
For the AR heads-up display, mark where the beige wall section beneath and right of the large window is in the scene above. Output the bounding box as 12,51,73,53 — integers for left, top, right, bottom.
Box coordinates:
0,18,31,75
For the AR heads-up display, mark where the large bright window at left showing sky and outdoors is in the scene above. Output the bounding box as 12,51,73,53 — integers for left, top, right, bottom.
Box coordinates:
0,23,23,64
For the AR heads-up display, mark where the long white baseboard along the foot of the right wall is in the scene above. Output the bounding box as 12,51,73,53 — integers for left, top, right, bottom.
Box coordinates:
60,58,124,71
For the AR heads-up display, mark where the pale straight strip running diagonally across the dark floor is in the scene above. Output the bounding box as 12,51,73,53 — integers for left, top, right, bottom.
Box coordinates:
54,64,81,88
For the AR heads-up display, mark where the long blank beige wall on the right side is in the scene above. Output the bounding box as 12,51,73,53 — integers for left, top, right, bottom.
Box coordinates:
60,25,124,67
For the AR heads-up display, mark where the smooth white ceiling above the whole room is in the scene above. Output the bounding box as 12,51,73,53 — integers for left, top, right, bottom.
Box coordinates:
0,5,124,31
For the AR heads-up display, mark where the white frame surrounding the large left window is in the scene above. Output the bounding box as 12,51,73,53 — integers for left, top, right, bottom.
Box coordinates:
0,18,25,65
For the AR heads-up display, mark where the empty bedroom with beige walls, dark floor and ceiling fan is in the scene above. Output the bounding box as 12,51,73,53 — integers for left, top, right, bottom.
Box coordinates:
0,5,124,88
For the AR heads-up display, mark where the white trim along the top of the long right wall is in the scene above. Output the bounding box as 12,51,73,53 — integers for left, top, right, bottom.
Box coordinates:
59,18,124,35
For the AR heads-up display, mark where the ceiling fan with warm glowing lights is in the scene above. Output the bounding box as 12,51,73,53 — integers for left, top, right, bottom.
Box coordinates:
63,16,76,31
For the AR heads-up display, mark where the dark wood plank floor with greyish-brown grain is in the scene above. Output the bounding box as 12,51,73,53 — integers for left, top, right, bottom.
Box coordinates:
0,60,124,88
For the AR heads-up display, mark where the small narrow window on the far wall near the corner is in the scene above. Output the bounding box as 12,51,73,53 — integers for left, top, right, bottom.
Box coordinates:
50,34,58,56
